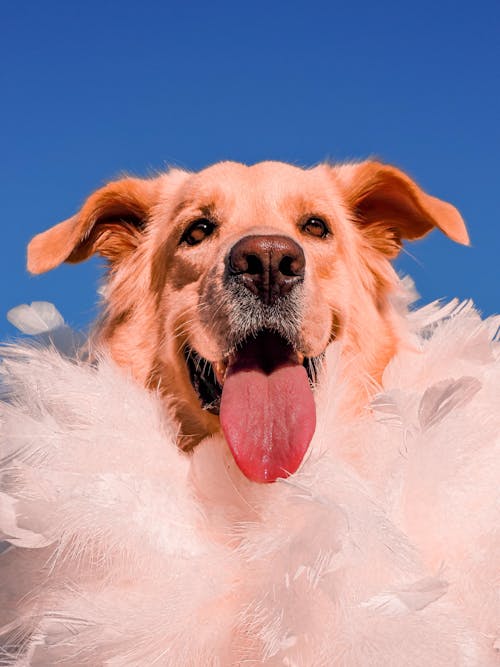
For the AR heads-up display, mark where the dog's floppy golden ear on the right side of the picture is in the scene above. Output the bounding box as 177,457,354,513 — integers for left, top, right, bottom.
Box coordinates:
335,161,469,257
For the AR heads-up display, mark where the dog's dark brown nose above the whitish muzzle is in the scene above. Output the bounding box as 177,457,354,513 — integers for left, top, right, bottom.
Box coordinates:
226,234,306,305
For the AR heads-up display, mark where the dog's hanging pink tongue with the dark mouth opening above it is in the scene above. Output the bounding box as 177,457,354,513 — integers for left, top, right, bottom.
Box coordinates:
220,333,316,482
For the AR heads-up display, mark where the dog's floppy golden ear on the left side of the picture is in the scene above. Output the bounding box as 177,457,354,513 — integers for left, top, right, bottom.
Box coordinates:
27,178,157,273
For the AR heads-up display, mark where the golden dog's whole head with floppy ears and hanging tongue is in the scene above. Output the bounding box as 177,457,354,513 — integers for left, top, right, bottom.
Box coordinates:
28,162,468,481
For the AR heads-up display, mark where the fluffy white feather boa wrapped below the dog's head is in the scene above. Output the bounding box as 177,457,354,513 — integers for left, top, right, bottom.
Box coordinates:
0,294,500,667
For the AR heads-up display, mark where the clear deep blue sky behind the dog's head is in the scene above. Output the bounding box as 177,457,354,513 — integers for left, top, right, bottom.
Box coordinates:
0,0,500,338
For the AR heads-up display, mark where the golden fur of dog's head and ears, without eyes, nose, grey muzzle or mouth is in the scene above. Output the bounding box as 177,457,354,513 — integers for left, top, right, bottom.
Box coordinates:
28,161,468,447
